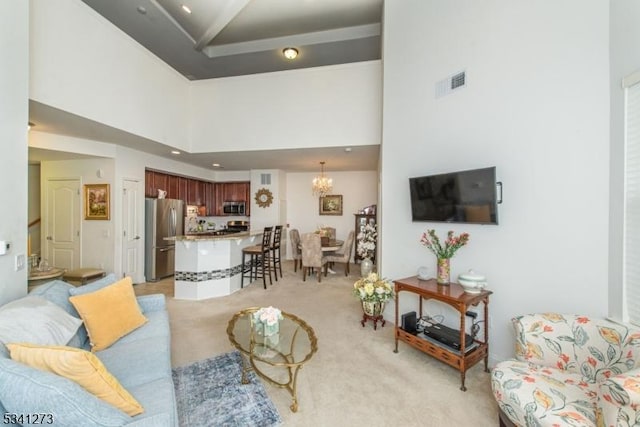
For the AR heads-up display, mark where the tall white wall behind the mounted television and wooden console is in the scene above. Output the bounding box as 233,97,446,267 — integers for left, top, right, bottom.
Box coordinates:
381,0,609,361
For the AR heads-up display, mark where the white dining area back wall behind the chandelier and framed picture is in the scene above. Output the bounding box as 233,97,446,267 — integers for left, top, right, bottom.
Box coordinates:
287,171,380,260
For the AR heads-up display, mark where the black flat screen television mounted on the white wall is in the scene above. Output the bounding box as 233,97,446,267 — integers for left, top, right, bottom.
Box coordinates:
409,167,498,224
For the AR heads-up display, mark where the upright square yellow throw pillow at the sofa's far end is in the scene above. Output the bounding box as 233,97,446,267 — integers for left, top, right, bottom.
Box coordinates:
69,277,147,352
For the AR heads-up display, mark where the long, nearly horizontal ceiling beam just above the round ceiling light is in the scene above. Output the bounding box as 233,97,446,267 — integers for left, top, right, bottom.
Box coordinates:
202,24,380,58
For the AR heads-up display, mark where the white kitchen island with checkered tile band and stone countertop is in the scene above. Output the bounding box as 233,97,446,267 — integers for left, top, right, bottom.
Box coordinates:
168,231,262,300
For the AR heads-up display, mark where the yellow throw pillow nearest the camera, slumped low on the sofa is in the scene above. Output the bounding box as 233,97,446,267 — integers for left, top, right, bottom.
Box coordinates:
7,343,144,416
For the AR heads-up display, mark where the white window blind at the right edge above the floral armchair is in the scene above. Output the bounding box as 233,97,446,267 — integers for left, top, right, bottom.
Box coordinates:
624,77,640,325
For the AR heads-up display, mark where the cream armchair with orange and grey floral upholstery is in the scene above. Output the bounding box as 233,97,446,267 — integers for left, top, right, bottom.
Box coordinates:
491,313,640,427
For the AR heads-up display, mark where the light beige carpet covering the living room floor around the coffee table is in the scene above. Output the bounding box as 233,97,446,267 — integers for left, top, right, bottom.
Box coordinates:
135,261,498,427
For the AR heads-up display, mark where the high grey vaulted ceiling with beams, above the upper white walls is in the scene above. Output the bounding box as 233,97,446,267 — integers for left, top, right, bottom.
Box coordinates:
83,0,383,80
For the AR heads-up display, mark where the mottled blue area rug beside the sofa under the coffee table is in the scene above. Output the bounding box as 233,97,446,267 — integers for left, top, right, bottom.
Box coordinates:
173,351,281,427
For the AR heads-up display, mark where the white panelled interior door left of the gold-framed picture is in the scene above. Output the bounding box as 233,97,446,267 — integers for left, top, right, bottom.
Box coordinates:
44,179,82,269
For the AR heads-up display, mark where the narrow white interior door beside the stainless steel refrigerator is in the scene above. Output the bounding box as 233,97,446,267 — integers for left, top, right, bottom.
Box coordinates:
122,179,144,283
